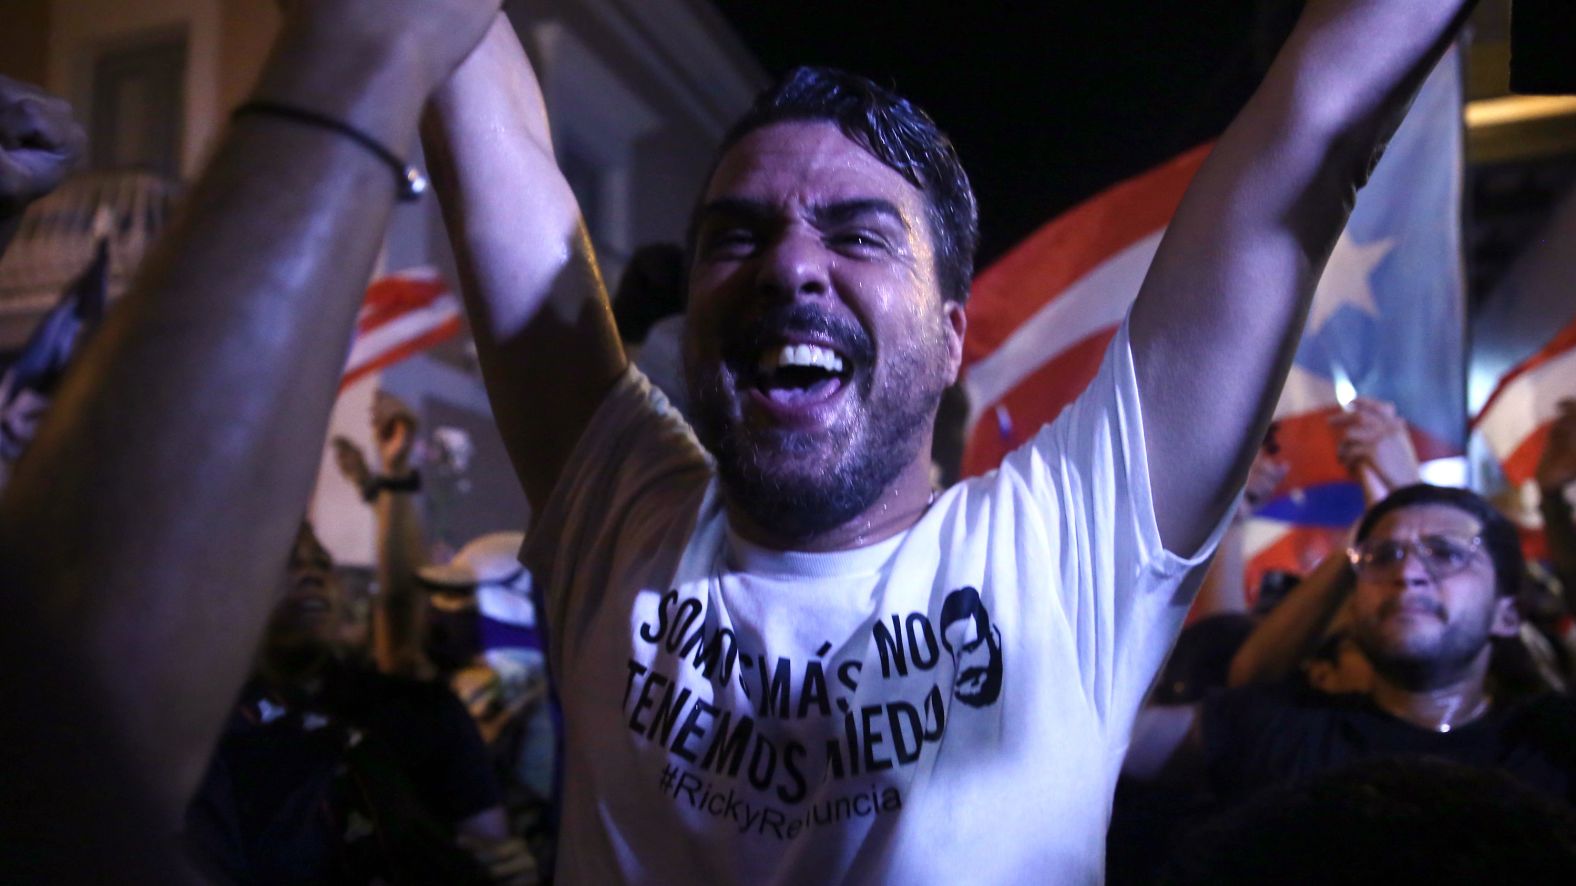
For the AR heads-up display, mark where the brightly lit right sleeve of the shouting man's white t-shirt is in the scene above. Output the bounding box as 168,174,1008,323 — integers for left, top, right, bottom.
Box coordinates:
993,315,1229,731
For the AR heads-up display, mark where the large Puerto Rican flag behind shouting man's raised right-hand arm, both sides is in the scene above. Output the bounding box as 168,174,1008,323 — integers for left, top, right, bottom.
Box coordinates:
963,52,1466,588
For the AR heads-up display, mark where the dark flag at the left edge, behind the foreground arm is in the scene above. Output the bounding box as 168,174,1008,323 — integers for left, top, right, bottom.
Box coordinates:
0,240,109,462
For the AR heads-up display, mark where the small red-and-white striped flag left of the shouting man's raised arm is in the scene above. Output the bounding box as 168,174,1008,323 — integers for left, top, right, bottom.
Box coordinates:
339,268,460,391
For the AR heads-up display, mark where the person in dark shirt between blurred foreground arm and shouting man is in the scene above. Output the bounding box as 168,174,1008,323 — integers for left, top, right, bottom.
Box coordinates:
186,523,536,883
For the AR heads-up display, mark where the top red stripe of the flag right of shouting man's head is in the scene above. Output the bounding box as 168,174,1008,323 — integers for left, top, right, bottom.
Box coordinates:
963,145,1210,364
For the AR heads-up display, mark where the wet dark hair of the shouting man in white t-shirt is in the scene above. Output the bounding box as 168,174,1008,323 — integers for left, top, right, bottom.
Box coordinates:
689,66,979,303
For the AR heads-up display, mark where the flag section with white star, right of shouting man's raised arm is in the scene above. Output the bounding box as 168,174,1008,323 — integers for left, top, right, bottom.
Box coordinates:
1247,52,1466,586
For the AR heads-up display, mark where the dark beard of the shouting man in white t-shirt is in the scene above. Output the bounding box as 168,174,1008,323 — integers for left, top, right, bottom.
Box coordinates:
686,302,946,539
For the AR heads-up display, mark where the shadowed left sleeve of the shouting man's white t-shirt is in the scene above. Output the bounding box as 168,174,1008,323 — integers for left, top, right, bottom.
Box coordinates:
522,366,711,673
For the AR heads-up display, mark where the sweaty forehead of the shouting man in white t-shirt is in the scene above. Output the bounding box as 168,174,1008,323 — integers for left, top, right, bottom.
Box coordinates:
706,121,924,214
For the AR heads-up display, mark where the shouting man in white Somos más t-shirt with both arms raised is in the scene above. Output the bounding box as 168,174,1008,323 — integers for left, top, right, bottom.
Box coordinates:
424,0,1466,881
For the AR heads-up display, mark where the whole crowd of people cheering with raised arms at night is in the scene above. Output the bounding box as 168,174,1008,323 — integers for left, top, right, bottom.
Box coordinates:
0,0,1576,883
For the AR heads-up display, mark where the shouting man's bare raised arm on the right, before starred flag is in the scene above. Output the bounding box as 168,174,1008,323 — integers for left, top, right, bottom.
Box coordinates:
1132,0,1472,552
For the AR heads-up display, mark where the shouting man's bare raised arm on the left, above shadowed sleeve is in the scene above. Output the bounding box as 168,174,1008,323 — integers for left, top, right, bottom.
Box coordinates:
422,16,626,508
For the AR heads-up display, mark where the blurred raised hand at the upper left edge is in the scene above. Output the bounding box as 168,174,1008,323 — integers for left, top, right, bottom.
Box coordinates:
0,74,87,254
